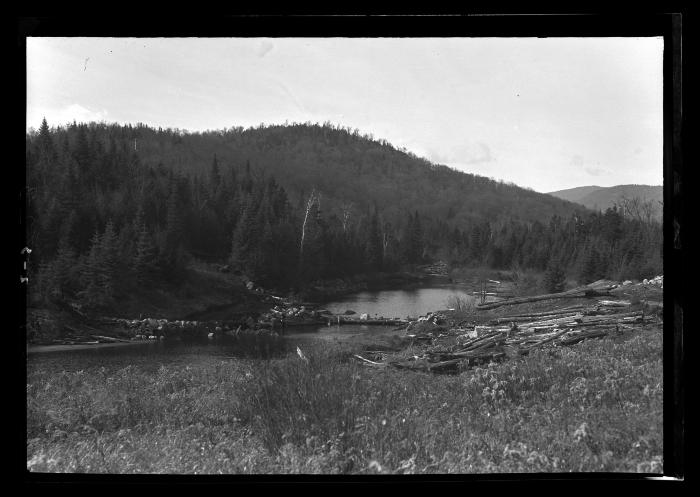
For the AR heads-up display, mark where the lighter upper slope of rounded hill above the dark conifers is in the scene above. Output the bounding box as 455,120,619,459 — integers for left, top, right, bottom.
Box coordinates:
121,124,581,225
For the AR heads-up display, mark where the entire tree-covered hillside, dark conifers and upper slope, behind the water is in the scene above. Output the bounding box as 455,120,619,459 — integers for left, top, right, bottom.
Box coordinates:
26,121,662,309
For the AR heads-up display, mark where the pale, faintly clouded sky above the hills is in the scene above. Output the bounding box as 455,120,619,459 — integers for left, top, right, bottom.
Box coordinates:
26,38,663,192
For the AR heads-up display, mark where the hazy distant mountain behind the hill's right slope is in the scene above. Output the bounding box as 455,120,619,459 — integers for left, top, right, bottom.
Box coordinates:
549,185,663,219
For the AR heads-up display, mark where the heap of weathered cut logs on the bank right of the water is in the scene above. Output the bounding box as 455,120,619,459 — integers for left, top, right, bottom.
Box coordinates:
355,300,656,373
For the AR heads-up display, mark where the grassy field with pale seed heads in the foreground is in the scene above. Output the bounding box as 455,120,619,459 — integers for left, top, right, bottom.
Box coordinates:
27,326,663,474
